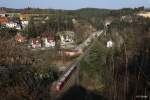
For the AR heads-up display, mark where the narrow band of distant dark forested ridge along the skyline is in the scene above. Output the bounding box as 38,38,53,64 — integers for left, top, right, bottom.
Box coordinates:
0,7,144,15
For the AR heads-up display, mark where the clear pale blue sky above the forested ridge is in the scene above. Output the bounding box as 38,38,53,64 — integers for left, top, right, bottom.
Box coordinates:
0,0,150,10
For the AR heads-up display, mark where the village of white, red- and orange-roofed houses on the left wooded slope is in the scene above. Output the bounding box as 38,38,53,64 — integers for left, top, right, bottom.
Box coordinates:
0,10,81,50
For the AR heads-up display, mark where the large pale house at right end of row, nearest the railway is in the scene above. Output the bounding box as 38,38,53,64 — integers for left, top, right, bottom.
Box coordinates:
57,31,75,48
